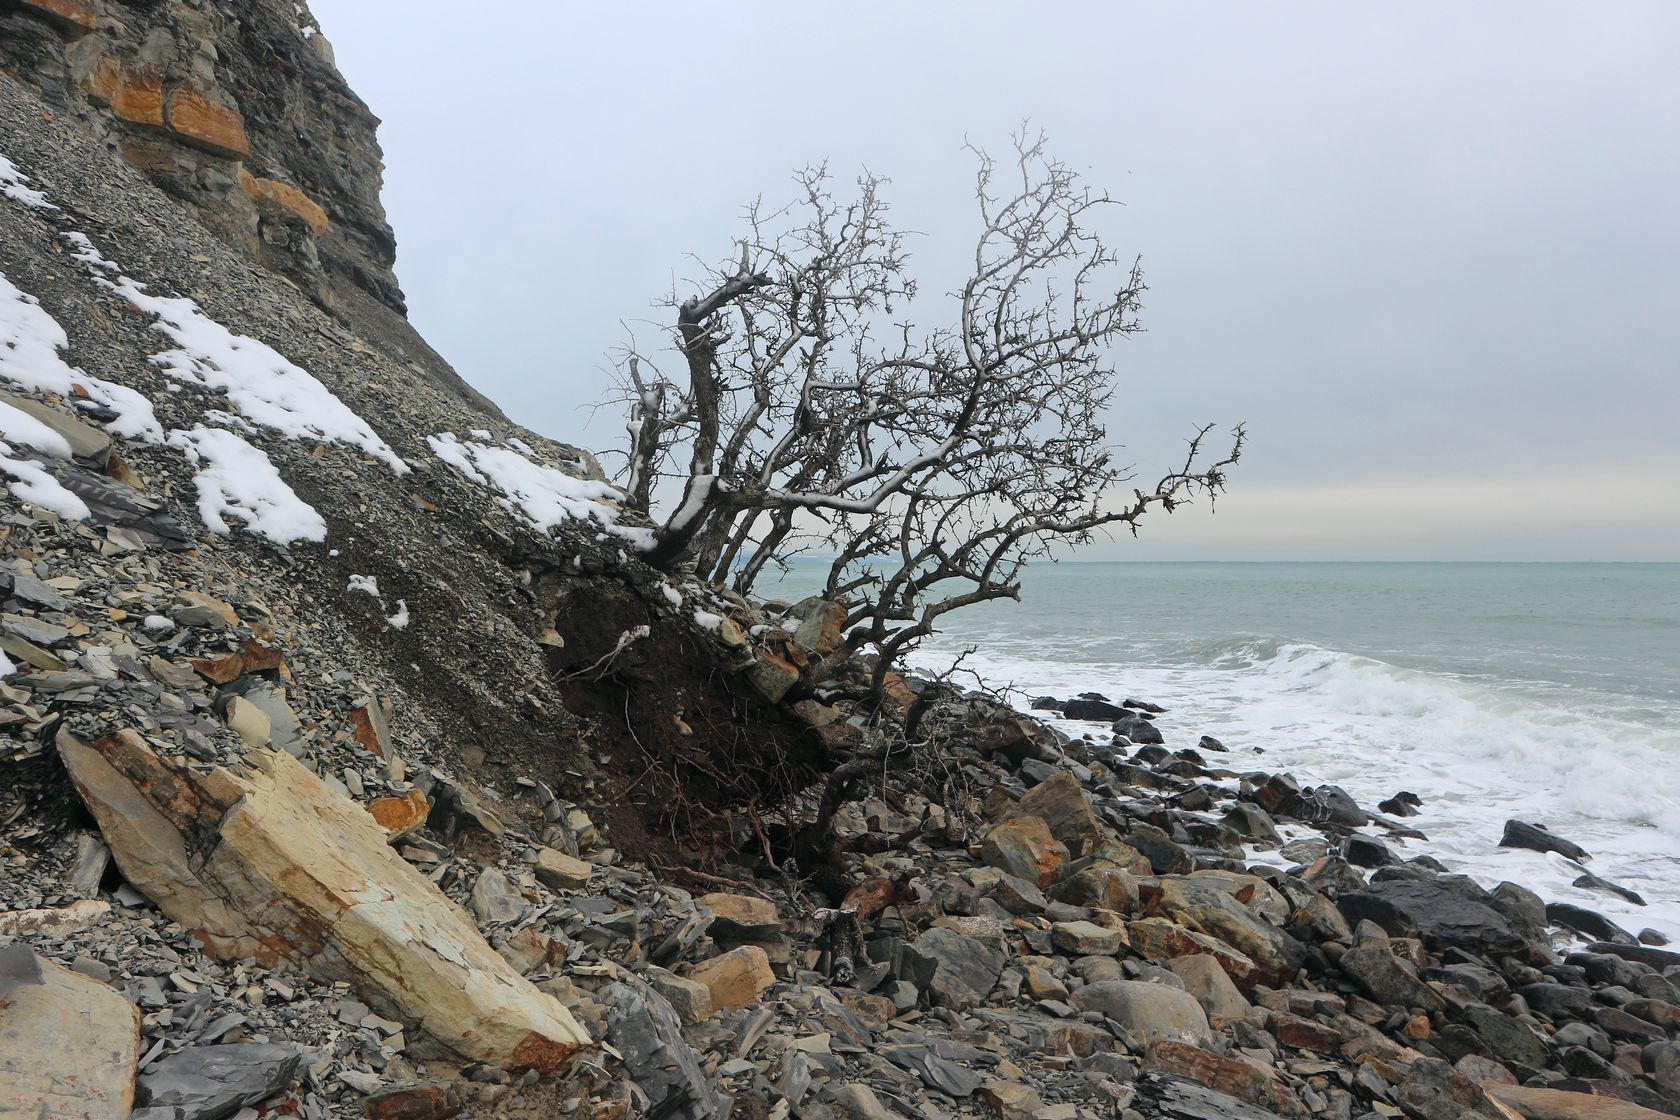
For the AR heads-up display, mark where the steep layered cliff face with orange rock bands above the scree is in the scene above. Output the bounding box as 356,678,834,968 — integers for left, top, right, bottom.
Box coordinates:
0,0,403,314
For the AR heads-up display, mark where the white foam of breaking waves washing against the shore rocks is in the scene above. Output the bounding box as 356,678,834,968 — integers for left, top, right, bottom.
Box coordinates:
921,643,1680,940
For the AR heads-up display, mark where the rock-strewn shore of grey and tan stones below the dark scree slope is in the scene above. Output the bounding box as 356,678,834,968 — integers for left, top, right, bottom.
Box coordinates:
0,493,1680,1120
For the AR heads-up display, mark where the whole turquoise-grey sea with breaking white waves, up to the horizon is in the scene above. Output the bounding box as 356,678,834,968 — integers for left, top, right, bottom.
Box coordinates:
759,561,1680,944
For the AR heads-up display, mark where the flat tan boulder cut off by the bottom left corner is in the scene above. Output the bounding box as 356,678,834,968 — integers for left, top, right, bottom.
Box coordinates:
0,944,139,1120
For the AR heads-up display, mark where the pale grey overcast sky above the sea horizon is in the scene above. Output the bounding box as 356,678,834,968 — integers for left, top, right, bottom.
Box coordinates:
311,0,1680,561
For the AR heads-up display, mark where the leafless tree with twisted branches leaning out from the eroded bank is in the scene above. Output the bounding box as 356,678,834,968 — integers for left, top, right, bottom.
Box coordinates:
620,133,1243,690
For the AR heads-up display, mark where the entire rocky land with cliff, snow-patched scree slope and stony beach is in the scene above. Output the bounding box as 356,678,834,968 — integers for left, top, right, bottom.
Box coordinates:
0,0,1680,1120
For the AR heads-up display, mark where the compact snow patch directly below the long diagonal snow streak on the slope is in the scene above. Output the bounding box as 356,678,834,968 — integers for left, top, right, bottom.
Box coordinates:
170,425,326,544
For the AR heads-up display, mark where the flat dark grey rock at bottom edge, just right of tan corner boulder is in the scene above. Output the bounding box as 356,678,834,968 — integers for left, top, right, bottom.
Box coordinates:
134,1043,302,1120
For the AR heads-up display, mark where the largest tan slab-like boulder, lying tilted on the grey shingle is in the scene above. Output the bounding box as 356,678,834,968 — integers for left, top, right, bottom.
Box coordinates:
59,732,590,1073
